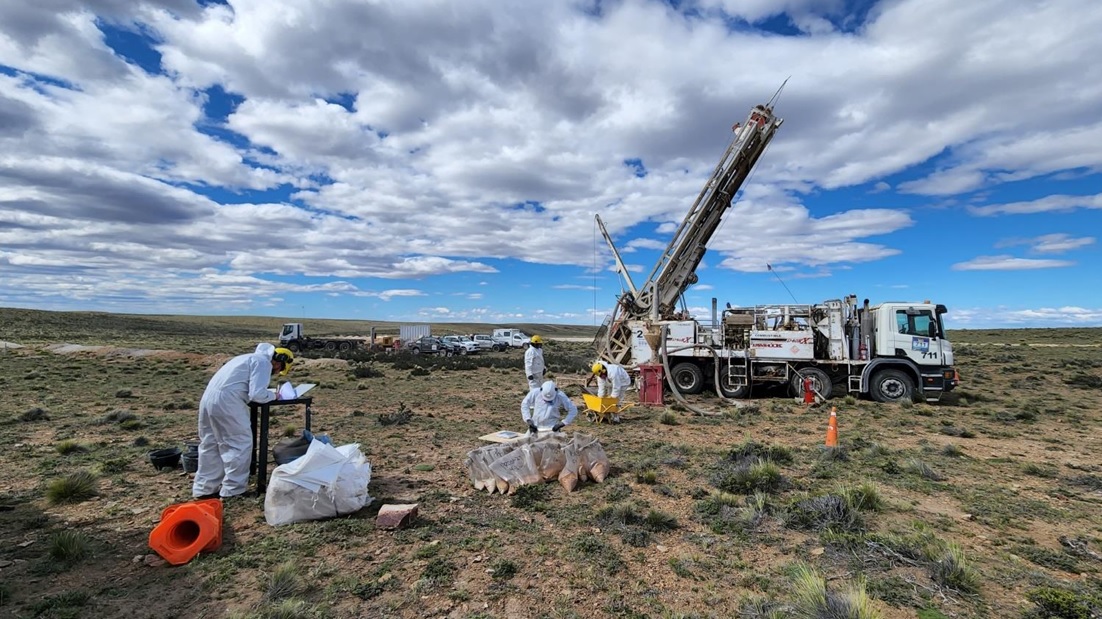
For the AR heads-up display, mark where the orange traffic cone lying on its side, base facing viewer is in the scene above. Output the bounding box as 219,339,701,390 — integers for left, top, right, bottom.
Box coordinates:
149,499,222,565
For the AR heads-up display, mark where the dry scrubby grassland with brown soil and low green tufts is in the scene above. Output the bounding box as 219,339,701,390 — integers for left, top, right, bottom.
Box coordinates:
0,310,1102,619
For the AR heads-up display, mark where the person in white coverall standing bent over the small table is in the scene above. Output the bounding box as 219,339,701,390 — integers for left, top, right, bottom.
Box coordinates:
192,344,294,499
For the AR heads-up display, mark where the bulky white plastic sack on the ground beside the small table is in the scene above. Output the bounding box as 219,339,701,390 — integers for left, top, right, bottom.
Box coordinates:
264,439,371,526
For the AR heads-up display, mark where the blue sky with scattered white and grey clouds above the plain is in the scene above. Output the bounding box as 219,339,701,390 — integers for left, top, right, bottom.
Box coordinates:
0,0,1102,328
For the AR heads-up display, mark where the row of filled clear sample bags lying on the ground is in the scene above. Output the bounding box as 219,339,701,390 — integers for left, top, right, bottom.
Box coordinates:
464,432,609,495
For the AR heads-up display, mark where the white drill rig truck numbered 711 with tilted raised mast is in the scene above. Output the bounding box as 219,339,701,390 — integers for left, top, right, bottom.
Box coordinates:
594,97,959,402
